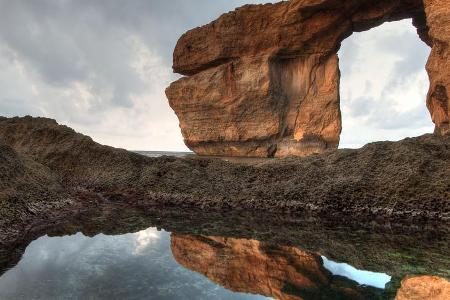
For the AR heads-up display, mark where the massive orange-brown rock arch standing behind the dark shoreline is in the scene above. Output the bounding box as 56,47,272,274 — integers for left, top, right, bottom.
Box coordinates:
166,0,450,157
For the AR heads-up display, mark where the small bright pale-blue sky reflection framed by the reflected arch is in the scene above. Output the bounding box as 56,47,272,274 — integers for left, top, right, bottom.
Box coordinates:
322,256,391,289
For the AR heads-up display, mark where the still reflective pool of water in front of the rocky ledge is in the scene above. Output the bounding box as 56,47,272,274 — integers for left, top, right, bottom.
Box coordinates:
0,209,450,299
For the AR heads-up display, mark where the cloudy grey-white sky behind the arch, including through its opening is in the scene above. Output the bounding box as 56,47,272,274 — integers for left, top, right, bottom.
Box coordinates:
0,0,433,151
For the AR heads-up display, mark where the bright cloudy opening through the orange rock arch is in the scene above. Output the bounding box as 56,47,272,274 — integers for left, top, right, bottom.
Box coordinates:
338,19,434,148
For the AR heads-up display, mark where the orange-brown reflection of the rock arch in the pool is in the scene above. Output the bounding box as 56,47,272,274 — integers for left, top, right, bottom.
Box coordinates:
171,233,383,300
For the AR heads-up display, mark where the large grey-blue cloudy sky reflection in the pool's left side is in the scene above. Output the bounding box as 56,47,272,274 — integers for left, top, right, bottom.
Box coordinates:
0,228,264,299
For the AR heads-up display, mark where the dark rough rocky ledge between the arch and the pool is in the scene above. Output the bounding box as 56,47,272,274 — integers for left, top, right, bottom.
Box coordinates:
0,117,450,246
